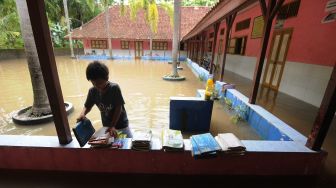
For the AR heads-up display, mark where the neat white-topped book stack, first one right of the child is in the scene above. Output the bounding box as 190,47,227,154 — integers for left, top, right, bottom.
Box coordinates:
132,130,152,151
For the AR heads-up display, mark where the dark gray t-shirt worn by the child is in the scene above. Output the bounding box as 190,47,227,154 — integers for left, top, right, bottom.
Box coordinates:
84,81,128,129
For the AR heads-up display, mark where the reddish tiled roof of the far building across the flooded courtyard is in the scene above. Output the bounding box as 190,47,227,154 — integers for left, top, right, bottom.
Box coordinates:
72,6,210,40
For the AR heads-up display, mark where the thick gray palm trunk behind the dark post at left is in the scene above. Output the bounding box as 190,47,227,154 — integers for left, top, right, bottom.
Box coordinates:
16,0,51,116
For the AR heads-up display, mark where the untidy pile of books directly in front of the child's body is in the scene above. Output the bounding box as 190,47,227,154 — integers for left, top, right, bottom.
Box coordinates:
88,127,114,147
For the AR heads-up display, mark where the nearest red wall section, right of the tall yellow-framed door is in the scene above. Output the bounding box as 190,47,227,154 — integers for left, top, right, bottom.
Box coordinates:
284,0,336,66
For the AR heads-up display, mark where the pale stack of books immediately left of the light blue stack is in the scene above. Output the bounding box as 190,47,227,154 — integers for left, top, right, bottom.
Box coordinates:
162,129,184,151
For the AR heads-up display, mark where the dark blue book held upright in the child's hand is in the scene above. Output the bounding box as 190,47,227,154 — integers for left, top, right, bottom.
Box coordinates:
72,119,95,147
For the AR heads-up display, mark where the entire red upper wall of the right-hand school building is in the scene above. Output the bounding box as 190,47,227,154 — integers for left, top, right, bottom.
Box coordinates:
207,0,336,66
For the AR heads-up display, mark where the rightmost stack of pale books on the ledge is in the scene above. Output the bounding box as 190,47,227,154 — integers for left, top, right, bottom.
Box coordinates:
215,133,246,155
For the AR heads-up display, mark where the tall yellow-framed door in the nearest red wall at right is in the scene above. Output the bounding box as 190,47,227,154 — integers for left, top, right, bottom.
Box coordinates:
262,28,293,91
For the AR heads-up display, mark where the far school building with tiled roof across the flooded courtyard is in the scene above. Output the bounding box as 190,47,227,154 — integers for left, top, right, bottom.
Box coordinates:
72,6,210,58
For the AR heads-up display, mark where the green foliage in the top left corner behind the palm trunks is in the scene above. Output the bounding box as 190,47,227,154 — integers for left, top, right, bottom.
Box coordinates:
0,0,100,49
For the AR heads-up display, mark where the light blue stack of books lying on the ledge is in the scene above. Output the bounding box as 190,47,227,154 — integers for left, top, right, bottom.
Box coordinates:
192,133,221,154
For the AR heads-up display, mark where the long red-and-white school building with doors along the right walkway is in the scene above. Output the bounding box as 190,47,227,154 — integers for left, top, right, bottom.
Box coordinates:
182,0,336,106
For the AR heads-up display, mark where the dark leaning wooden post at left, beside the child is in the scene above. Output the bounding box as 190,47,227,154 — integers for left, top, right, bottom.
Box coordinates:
27,0,72,144
